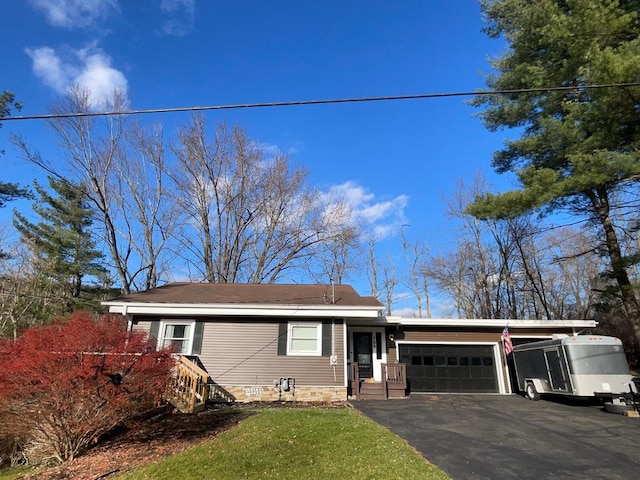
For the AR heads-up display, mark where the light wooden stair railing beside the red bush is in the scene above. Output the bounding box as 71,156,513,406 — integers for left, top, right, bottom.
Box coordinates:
168,357,209,413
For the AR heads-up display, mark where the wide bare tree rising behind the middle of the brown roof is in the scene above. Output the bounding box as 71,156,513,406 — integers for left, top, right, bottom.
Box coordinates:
166,115,357,283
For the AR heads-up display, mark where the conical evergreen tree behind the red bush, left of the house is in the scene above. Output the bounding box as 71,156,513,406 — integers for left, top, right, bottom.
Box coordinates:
14,177,106,307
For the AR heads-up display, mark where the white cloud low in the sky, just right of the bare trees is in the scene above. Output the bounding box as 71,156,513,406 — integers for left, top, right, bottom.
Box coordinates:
325,181,409,239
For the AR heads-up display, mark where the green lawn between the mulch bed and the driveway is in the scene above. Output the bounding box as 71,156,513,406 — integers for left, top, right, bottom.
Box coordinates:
117,408,449,480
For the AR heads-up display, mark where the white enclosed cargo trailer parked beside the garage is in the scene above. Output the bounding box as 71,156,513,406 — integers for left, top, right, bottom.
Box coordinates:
513,335,632,400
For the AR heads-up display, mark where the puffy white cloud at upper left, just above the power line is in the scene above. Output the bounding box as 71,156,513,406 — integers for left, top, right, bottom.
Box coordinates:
25,46,128,107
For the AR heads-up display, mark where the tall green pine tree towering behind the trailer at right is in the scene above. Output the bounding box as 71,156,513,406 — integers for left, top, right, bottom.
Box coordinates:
469,0,640,341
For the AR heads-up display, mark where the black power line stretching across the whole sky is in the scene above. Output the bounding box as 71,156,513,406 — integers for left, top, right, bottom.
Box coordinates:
0,82,640,122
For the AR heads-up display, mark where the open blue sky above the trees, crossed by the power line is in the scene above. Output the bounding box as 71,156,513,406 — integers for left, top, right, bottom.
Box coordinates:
0,0,509,314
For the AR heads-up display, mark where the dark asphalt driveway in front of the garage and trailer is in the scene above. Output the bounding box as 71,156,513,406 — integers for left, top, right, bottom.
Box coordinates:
352,394,640,480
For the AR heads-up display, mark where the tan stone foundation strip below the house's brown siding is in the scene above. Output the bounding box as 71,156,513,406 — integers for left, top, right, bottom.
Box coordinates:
222,385,347,403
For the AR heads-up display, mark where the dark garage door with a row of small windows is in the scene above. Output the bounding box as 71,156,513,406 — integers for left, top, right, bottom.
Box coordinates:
398,344,500,393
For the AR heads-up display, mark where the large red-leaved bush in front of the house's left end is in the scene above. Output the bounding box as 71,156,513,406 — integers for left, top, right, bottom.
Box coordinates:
0,313,173,464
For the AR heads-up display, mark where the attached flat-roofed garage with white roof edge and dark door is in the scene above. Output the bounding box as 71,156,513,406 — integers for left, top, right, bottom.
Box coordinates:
386,317,596,394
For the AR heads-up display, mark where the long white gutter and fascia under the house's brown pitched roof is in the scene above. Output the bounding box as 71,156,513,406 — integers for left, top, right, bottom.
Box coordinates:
102,301,381,318
